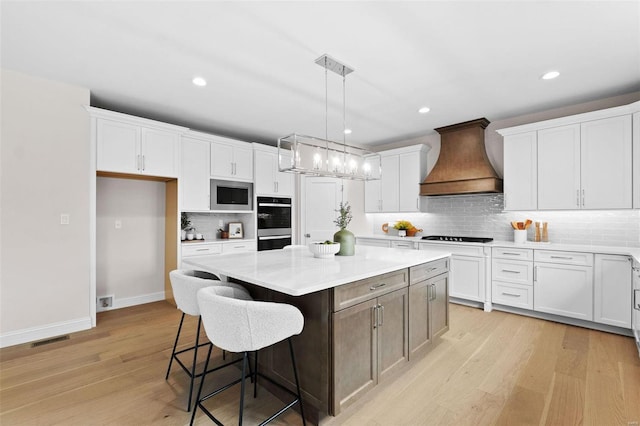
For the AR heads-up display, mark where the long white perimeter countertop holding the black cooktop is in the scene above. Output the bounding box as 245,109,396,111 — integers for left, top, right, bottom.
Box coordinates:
357,234,640,262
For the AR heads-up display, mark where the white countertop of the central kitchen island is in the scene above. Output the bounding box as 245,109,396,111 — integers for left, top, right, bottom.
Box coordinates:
183,246,451,296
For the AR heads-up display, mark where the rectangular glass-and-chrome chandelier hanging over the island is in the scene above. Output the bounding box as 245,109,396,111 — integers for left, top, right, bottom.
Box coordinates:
278,54,382,180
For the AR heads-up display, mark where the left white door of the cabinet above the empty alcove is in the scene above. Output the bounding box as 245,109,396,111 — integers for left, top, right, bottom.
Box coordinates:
97,119,141,174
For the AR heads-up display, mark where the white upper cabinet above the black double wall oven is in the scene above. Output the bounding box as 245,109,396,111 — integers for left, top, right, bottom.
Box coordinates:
253,144,293,197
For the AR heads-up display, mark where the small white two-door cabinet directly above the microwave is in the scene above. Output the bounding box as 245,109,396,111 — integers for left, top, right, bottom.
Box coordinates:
211,137,253,182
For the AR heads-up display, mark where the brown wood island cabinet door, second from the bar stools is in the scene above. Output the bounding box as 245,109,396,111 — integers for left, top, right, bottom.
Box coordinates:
377,288,409,382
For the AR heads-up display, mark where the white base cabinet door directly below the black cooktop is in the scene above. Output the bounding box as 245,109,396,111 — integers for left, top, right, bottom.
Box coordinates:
449,255,485,303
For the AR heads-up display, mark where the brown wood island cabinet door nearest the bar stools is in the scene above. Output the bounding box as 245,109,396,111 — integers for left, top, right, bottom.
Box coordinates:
333,299,378,415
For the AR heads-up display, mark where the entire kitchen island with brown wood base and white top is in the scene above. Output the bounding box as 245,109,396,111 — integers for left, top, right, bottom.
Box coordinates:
184,246,450,424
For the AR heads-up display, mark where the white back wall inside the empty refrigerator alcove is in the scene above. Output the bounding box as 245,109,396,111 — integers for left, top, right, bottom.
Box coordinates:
96,177,165,310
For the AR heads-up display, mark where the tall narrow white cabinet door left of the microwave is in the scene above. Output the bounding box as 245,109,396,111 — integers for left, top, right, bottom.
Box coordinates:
180,137,211,211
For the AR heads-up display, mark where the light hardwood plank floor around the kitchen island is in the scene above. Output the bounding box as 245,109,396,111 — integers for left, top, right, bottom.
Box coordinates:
0,302,640,426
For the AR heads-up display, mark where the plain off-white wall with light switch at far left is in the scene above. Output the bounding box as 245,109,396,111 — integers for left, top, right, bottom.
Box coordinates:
0,69,91,346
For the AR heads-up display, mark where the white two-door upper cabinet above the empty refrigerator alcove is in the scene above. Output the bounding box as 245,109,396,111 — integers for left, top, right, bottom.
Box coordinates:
95,113,184,177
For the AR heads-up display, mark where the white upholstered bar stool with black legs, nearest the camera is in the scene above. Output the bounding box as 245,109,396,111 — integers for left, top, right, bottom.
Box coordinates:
191,287,306,425
